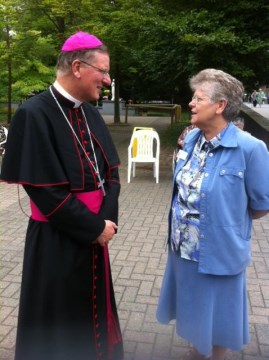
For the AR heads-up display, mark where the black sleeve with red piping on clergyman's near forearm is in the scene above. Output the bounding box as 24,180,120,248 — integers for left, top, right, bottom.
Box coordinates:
24,185,105,244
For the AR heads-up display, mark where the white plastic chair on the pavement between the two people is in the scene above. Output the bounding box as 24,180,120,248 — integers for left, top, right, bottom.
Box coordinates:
127,129,160,184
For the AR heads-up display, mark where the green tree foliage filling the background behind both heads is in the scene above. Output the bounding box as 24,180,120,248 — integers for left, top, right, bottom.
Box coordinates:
0,0,269,115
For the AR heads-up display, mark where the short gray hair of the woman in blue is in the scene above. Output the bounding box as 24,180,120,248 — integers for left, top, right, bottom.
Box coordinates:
190,69,244,121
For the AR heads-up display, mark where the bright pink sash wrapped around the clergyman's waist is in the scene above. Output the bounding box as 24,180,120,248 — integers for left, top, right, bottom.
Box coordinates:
30,189,104,222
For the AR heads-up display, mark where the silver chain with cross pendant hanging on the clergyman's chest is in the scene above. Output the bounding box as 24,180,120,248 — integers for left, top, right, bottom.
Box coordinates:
49,86,106,196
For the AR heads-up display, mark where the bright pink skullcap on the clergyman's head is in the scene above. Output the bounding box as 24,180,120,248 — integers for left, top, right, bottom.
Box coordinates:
61,31,103,52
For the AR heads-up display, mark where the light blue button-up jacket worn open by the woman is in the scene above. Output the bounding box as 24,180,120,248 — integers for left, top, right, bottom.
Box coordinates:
168,123,269,275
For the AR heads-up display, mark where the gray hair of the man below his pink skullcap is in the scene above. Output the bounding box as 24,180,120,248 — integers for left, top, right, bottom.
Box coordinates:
56,45,109,75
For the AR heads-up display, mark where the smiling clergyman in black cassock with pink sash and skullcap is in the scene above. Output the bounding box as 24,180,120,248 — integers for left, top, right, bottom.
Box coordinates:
1,31,123,360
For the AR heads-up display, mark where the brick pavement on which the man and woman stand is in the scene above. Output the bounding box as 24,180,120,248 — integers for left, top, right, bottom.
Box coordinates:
0,117,269,360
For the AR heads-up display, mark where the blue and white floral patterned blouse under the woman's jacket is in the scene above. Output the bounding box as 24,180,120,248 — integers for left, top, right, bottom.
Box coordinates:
171,131,224,261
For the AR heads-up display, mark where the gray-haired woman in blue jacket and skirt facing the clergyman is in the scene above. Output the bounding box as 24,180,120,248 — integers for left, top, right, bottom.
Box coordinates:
157,69,269,360
